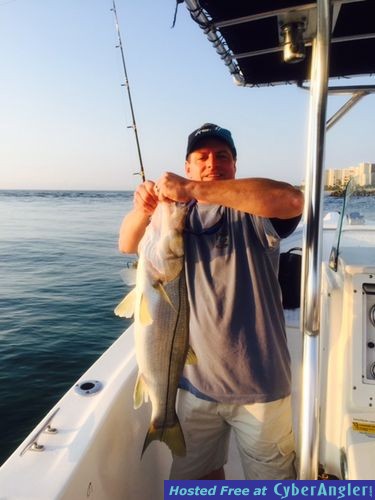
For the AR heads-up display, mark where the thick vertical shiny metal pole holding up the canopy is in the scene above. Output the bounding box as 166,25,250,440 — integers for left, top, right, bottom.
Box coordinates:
299,0,331,479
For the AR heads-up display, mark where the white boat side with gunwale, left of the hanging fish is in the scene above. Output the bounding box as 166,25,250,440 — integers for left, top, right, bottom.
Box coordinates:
0,327,171,500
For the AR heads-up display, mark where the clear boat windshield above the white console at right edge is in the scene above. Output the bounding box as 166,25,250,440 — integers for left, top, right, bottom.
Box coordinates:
329,174,375,271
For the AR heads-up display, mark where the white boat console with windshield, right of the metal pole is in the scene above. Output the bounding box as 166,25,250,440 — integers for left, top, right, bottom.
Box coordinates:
320,180,375,479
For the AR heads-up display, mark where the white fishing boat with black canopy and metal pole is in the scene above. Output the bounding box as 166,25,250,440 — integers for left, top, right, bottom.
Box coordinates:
0,0,375,500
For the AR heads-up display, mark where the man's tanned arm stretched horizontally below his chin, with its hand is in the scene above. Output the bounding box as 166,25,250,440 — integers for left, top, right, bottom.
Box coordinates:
156,172,303,219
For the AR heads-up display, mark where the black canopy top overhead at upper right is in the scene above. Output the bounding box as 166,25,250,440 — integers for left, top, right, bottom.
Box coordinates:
185,0,375,86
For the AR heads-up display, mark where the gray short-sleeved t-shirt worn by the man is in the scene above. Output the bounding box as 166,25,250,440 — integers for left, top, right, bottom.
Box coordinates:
180,204,296,404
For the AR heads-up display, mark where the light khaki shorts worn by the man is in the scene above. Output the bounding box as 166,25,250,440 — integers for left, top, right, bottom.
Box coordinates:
170,390,296,480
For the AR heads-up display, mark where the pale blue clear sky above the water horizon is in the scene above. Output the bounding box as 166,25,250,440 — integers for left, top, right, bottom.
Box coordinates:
0,0,375,190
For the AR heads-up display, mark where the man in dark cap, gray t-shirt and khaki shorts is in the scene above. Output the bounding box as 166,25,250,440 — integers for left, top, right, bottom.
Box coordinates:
119,123,303,480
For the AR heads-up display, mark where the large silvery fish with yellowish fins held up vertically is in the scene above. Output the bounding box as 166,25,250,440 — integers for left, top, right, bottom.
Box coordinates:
115,201,197,457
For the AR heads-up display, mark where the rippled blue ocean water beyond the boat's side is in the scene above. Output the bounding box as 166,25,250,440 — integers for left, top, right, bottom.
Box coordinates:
0,191,374,463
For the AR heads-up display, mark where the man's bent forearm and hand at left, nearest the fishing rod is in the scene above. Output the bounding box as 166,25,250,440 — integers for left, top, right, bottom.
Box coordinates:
118,181,158,253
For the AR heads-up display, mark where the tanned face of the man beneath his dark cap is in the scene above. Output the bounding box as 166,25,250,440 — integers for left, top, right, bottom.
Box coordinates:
185,139,236,181
